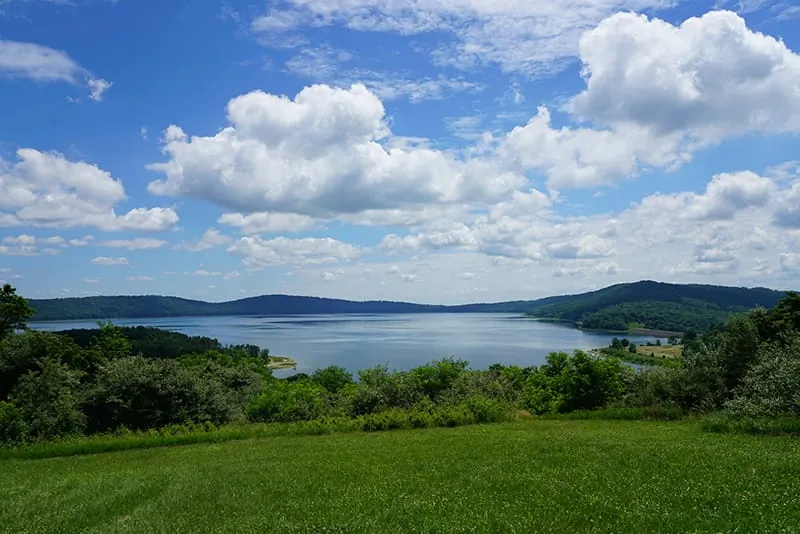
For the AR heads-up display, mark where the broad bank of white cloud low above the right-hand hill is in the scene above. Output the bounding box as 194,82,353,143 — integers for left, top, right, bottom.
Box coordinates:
368,172,800,294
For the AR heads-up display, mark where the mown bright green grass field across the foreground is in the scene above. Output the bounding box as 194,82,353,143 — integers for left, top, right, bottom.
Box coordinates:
0,420,800,533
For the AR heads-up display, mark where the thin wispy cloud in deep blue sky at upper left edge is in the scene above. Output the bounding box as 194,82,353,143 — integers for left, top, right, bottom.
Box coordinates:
0,40,112,102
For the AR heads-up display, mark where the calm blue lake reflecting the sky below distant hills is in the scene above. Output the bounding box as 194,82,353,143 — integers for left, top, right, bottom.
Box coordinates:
30,314,654,376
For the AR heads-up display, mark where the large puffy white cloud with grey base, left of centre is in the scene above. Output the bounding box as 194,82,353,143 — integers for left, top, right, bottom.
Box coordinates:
148,85,525,216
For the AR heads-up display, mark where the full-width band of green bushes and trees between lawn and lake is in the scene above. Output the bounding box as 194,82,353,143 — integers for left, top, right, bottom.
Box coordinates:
0,291,800,443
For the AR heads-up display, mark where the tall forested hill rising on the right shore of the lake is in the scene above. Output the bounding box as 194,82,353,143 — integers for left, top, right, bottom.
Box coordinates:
528,281,786,332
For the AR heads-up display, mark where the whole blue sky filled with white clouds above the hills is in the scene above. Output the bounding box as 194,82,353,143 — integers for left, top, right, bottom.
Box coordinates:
0,0,800,304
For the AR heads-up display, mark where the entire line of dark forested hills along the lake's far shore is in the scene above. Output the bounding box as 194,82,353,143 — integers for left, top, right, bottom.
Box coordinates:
30,281,785,331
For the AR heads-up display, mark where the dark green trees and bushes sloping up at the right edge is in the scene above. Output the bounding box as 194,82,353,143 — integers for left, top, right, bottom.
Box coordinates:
625,293,800,426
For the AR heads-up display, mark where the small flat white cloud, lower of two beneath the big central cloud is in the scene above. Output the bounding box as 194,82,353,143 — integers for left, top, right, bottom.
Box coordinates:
228,236,363,269
